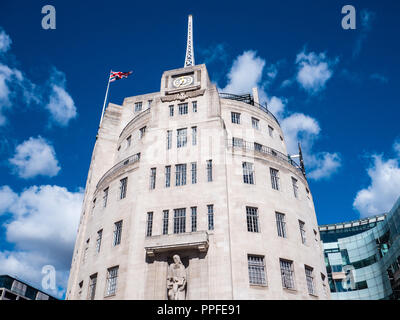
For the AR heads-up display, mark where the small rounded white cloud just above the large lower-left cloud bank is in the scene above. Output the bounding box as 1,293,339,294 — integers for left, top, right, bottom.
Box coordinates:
9,136,61,179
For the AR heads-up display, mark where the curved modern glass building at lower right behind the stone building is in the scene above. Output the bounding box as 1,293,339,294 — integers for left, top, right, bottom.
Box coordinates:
319,198,400,300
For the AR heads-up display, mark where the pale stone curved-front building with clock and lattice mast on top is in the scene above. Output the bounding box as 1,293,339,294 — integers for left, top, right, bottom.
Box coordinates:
67,18,330,299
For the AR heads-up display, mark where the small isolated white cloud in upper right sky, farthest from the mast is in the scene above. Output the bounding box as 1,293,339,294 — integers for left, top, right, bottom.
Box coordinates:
296,51,337,94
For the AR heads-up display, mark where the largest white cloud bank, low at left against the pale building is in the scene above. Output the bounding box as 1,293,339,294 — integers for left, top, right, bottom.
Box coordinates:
0,185,83,296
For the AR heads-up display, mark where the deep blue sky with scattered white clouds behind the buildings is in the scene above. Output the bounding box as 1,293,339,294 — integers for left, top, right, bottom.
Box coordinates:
0,0,400,296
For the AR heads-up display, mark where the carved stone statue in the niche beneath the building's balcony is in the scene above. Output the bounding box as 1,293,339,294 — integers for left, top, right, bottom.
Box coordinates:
167,254,186,300
